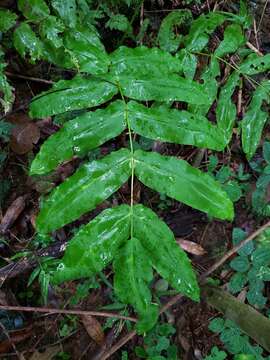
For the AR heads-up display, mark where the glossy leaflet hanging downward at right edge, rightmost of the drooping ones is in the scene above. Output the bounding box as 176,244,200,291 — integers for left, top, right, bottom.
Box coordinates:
241,81,270,159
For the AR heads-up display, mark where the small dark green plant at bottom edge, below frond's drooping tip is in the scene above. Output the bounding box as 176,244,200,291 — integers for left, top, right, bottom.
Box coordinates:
135,323,178,360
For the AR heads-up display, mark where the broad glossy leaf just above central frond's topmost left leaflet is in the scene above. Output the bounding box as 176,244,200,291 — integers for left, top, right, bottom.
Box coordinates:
64,26,109,75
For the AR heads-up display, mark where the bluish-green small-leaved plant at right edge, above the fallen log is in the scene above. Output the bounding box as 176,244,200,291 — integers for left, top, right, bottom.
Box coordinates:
229,228,270,308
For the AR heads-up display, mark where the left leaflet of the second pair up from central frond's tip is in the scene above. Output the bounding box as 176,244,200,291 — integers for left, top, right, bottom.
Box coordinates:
37,149,131,233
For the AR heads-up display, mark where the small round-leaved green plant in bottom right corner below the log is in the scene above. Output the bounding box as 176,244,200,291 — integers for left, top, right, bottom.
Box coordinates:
205,317,270,360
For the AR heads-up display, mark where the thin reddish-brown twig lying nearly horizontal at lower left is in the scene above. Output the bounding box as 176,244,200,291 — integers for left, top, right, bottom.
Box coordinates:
0,305,137,322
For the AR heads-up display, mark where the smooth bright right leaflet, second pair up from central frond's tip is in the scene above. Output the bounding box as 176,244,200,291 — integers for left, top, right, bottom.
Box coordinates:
135,150,234,220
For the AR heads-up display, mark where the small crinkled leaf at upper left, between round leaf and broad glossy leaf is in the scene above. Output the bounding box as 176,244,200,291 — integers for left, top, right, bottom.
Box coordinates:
39,16,65,51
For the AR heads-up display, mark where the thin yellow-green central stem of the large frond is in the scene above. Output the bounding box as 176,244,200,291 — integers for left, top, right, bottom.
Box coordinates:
117,83,134,238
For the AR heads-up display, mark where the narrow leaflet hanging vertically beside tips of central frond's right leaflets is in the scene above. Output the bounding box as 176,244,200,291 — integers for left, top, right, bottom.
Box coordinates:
216,72,239,143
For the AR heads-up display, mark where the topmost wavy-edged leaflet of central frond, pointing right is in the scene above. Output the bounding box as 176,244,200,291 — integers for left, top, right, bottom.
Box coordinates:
110,46,182,79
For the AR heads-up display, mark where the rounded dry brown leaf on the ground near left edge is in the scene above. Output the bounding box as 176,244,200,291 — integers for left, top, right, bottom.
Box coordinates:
10,121,40,155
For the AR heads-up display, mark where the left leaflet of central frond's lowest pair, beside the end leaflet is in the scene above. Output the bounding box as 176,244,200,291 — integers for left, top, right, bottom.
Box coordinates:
53,205,130,283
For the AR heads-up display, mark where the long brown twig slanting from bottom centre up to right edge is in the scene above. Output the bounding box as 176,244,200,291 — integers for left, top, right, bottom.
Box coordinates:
100,221,270,360
